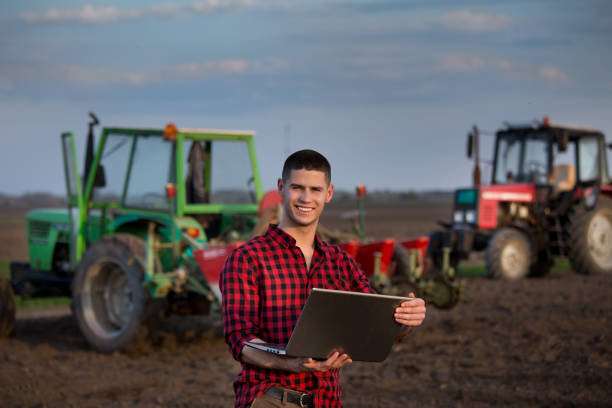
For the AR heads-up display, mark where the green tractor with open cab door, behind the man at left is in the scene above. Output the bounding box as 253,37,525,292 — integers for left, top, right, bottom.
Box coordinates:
0,114,262,352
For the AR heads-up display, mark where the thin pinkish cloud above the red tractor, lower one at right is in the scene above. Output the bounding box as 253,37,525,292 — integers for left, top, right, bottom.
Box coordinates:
438,54,569,82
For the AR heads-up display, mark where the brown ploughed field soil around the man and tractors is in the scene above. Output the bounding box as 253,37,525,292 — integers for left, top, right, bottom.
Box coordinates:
0,202,612,408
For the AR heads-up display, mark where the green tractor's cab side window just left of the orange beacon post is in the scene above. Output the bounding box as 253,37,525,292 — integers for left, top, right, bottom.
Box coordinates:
124,135,175,210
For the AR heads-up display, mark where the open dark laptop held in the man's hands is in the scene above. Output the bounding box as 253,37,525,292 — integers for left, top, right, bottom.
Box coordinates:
245,288,412,362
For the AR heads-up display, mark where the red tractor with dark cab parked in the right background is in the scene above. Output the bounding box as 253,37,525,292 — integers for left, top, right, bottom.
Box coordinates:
428,118,612,279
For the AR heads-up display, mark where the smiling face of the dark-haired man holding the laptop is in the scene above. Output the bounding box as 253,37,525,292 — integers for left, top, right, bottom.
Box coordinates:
278,169,334,227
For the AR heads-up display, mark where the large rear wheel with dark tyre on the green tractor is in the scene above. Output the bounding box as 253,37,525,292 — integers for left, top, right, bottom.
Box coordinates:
72,234,164,352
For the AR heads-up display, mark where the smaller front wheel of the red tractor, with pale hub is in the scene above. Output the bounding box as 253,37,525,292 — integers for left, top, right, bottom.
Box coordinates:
486,228,531,279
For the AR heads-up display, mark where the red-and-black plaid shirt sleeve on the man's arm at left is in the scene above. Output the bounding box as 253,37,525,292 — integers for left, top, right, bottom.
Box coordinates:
220,248,259,361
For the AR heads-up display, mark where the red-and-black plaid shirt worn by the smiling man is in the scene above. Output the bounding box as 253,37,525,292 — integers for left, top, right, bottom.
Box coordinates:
220,225,375,407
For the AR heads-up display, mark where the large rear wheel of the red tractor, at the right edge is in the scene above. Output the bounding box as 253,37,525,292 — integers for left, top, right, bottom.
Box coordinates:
568,196,612,275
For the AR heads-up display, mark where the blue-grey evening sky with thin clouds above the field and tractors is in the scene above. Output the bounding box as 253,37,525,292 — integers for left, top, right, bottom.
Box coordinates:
0,0,612,195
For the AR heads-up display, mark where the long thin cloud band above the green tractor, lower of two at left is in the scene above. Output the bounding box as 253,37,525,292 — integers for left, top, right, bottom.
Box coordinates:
0,58,287,89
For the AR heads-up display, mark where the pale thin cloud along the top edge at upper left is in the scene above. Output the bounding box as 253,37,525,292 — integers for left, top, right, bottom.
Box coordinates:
21,0,255,24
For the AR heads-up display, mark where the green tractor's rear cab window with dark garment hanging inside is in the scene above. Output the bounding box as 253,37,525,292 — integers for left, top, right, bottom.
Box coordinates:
183,140,257,204
